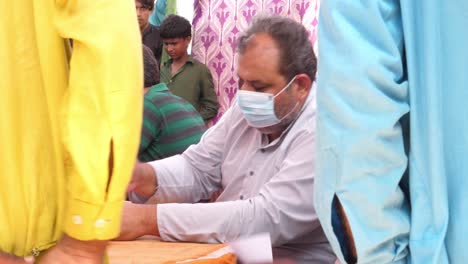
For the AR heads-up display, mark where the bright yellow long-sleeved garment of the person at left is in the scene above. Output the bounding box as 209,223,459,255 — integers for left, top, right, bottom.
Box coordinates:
0,0,143,256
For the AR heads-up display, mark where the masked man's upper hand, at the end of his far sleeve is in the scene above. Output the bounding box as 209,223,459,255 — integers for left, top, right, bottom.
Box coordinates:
127,162,158,197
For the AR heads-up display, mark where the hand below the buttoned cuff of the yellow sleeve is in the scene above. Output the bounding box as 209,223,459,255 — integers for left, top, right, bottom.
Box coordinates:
40,235,107,264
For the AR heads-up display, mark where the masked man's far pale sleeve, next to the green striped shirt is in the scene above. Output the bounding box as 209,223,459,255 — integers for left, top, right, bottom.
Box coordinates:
145,105,232,203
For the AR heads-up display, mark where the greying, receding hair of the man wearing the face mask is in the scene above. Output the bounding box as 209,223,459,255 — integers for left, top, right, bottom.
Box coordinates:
237,16,317,81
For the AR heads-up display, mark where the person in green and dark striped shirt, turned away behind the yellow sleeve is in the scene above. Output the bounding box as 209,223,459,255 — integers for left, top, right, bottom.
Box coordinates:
138,46,206,161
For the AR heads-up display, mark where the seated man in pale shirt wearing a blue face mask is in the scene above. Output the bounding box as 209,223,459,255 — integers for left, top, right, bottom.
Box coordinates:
120,16,336,263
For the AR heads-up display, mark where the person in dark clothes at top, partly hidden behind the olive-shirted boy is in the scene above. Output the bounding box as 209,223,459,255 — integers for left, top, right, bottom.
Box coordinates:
135,0,163,66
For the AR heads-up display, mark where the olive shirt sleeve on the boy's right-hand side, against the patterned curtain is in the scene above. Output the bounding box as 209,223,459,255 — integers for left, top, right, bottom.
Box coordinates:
200,66,219,121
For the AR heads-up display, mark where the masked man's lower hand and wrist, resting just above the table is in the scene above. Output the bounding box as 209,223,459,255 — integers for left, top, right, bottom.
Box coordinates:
115,202,159,240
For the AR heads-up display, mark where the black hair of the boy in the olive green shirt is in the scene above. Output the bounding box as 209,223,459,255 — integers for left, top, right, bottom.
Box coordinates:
159,15,192,39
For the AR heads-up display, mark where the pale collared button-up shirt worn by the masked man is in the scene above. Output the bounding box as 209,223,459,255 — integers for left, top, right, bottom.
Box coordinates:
133,89,335,263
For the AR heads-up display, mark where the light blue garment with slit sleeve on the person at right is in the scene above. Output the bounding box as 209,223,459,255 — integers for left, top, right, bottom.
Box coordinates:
315,0,468,264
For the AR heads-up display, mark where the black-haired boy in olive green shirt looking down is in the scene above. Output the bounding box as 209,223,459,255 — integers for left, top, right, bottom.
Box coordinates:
160,15,218,122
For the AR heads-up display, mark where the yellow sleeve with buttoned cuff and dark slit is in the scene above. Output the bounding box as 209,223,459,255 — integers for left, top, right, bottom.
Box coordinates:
54,0,143,240
